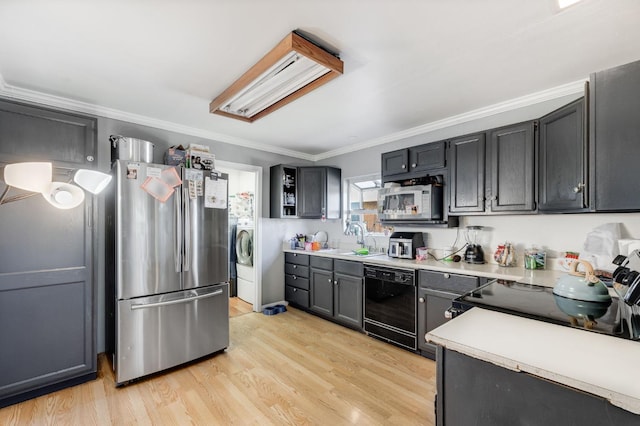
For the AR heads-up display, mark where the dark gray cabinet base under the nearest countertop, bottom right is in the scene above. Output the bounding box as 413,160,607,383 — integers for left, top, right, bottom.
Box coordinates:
436,346,640,426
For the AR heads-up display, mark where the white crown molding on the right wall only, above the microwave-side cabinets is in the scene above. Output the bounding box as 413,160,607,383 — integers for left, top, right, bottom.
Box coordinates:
315,78,588,161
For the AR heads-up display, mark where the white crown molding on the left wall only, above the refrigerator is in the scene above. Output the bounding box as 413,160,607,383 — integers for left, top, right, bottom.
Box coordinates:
0,74,316,161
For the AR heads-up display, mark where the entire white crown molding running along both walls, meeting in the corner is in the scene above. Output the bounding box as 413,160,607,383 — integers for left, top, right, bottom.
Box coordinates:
0,74,588,162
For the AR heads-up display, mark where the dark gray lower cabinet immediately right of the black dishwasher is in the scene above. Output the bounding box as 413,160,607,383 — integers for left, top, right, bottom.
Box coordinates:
417,271,486,359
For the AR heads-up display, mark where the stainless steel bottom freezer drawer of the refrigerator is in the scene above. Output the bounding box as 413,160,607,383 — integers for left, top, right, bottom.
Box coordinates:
114,283,229,385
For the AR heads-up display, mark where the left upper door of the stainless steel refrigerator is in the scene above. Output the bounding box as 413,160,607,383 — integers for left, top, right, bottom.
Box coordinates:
114,160,183,299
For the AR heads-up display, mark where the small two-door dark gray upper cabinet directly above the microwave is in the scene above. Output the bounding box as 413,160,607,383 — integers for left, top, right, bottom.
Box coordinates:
382,141,446,179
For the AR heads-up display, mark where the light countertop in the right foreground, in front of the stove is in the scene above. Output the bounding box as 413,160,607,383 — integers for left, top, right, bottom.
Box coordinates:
425,308,640,414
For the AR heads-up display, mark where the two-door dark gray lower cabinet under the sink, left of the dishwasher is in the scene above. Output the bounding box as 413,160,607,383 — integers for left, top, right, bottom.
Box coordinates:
309,256,364,330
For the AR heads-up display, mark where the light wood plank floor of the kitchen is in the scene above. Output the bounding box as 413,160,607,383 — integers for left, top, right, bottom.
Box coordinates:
0,308,435,425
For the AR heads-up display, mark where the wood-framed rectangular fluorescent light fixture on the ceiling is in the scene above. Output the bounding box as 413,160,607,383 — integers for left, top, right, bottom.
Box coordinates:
209,31,344,123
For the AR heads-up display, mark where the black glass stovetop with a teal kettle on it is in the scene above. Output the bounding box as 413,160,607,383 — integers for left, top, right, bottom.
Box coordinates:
453,280,629,339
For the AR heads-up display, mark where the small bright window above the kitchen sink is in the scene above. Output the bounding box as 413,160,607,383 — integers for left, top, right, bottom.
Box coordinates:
344,174,390,235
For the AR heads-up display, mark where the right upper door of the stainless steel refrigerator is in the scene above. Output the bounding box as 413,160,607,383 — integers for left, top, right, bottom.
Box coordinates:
183,172,229,289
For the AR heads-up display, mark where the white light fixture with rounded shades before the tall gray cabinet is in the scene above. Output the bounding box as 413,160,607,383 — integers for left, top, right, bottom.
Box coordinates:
0,162,111,209
